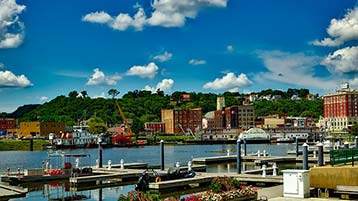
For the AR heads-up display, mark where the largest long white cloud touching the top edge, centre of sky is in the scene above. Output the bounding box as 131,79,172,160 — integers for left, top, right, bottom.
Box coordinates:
82,0,228,31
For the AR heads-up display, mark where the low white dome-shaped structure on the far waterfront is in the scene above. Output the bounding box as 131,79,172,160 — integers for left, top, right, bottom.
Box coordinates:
239,128,270,143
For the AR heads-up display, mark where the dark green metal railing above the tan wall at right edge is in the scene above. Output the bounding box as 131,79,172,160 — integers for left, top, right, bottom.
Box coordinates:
329,148,358,166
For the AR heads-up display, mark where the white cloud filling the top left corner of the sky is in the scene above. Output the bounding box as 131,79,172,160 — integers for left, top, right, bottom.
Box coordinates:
0,0,26,48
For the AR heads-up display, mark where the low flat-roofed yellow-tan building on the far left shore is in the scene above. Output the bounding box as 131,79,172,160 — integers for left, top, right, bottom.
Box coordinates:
17,121,66,137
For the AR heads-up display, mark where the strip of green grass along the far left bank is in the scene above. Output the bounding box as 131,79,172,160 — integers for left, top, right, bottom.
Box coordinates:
0,139,48,151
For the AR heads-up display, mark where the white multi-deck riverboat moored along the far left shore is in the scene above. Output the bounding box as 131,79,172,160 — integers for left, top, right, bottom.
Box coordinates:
44,126,98,149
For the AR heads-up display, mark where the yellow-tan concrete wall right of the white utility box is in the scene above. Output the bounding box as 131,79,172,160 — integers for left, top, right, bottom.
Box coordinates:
310,164,358,189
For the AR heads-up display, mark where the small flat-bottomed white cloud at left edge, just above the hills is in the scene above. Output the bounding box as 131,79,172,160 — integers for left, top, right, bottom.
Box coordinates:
0,70,32,88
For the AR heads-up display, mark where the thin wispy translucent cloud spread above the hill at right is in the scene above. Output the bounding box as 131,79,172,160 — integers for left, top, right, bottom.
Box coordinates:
254,51,339,89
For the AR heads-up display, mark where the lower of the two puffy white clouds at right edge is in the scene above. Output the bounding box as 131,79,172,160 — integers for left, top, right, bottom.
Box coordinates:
321,46,358,73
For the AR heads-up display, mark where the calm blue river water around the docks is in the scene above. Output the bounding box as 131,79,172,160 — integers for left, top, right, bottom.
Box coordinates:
0,144,294,200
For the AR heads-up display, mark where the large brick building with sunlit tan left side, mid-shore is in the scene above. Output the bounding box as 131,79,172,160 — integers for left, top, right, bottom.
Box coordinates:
161,108,202,134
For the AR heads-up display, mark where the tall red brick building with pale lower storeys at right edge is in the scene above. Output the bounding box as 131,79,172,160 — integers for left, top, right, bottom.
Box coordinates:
323,83,358,132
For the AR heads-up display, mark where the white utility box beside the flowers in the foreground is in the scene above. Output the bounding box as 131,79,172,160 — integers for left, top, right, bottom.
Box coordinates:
282,170,310,198
